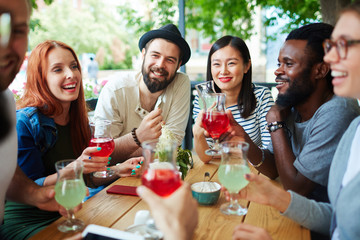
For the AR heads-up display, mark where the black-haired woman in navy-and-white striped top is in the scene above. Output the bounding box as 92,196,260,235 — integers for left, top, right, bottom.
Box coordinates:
193,36,274,162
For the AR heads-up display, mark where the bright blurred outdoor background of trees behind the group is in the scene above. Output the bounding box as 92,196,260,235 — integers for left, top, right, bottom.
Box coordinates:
10,0,351,99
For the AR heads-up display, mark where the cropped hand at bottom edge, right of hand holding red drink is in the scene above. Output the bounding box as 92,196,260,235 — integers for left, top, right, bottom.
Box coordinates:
233,223,272,240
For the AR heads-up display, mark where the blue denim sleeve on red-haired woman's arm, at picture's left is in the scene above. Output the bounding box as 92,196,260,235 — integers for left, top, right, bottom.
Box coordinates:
16,111,45,180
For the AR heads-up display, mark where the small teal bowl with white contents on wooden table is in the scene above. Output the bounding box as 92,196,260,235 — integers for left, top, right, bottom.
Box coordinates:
191,182,221,205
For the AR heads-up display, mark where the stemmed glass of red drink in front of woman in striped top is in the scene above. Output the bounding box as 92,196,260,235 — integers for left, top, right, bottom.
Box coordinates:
202,93,229,156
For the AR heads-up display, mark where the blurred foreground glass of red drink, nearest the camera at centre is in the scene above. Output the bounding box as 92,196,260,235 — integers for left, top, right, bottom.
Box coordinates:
141,140,181,197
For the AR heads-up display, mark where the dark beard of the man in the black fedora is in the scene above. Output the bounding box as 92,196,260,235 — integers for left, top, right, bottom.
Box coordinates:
141,62,176,93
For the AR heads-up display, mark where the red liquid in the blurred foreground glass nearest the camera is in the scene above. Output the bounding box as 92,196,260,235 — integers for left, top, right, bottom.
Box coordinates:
141,169,181,197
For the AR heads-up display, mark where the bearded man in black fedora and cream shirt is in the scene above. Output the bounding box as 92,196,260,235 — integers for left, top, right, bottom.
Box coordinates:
95,24,191,163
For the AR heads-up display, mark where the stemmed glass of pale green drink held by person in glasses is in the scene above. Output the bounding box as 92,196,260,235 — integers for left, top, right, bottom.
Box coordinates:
218,141,250,216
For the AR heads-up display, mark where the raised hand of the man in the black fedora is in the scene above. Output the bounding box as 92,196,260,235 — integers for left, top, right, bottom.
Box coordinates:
136,108,163,143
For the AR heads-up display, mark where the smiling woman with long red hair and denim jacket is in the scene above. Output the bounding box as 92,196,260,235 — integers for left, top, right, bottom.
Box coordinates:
0,41,142,239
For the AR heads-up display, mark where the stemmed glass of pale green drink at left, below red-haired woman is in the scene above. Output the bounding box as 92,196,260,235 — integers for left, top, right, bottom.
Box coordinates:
55,159,86,232
